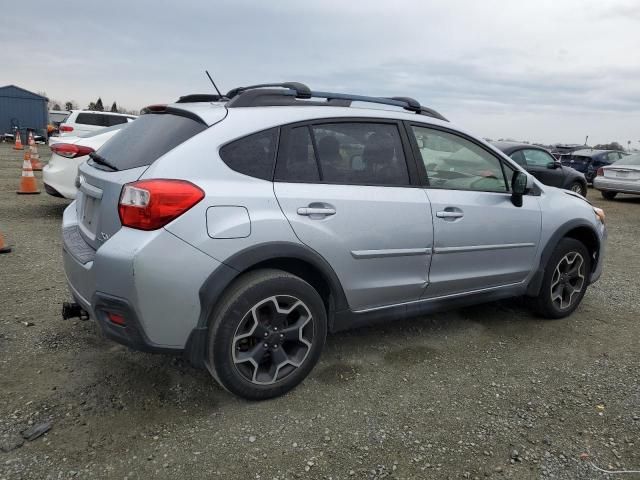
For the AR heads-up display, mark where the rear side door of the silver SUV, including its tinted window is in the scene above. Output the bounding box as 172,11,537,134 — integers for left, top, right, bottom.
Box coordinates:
274,119,433,310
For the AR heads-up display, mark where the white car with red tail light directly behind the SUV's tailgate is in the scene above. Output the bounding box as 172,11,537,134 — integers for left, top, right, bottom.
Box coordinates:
42,123,127,199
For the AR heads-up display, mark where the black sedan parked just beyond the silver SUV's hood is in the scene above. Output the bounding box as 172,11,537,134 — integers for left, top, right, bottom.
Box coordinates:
493,142,587,197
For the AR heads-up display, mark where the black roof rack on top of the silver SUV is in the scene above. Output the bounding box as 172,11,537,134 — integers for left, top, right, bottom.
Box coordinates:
226,82,448,122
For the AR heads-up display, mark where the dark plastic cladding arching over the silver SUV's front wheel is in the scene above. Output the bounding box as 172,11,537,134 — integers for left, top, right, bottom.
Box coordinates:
526,219,600,297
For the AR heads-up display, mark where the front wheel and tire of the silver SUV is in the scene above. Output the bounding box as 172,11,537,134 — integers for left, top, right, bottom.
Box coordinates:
534,238,591,319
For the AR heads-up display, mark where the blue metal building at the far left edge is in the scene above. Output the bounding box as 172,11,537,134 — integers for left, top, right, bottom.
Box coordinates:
0,85,49,143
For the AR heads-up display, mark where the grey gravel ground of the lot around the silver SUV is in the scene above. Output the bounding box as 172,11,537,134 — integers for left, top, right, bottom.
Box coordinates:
0,145,640,479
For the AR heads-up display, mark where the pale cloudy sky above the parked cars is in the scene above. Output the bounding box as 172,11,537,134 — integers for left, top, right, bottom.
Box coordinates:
0,0,640,148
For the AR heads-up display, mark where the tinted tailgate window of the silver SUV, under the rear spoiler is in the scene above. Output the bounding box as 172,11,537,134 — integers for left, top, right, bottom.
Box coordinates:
98,113,207,170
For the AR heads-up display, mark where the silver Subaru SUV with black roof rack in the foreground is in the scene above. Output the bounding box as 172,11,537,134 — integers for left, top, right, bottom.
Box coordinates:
63,83,606,399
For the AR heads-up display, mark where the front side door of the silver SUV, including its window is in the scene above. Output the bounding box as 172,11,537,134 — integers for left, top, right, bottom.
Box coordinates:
409,124,541,298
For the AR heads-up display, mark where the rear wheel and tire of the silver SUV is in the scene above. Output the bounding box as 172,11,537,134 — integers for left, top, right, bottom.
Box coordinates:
208,270,327,400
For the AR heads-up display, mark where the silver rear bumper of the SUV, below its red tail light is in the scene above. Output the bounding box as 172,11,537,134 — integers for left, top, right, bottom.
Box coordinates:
63,202,221,352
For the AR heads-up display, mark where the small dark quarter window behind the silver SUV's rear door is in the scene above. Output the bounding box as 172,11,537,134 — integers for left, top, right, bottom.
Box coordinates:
220,128,278,180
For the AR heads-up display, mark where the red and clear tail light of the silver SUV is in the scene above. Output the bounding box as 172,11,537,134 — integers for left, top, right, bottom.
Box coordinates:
118,180,204,230
